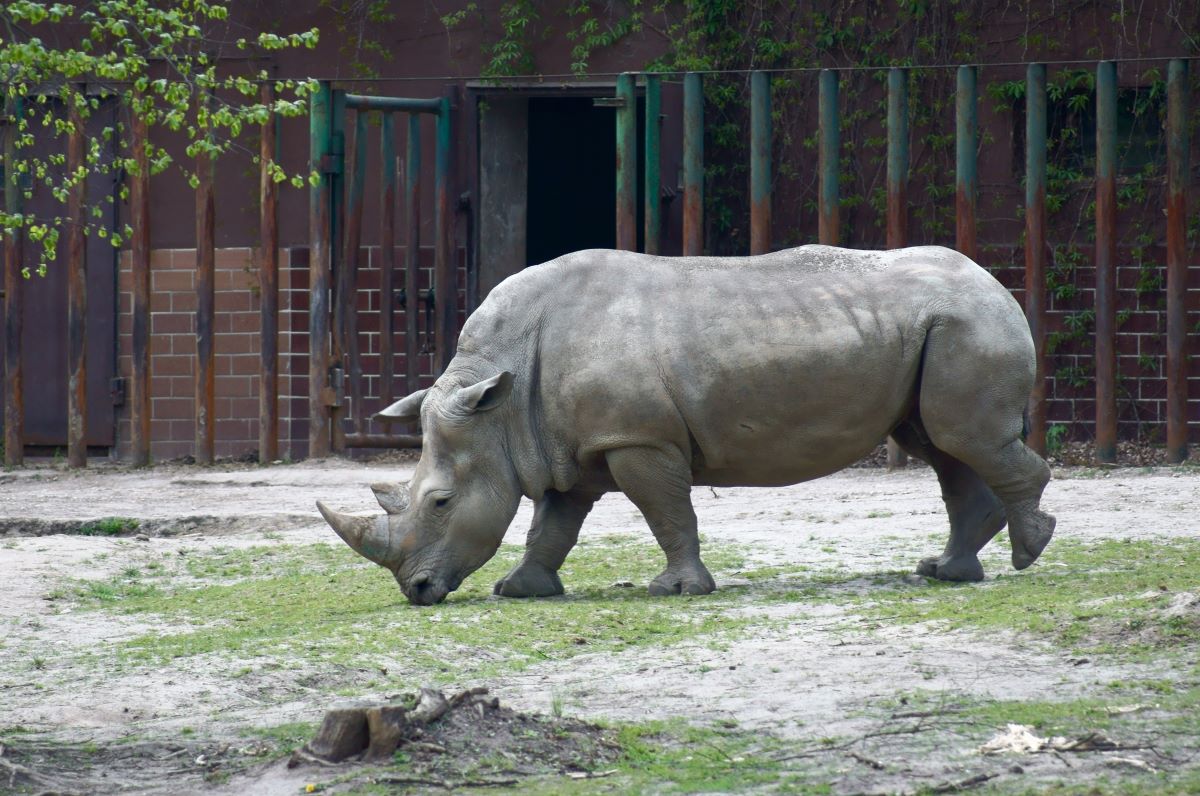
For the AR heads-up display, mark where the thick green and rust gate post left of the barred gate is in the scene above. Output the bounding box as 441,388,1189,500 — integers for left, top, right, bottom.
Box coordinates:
308,80,332,459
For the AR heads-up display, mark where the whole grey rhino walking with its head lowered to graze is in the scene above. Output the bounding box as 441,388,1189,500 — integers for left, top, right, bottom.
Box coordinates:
318,246,1055,605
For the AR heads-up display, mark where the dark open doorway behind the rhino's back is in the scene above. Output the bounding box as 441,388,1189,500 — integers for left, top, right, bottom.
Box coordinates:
526,97,643,265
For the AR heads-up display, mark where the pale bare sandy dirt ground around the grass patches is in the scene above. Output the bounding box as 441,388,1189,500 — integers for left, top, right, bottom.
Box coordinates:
0,460,1200,794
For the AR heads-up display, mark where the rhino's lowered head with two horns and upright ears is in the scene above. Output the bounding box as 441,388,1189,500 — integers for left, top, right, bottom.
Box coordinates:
317,371,521,605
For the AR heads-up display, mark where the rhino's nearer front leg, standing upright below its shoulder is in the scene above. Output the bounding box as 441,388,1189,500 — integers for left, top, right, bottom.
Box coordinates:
607,448,716,595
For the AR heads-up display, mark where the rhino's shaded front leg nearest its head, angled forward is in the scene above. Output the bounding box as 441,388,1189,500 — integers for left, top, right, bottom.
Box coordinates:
492,490,600,597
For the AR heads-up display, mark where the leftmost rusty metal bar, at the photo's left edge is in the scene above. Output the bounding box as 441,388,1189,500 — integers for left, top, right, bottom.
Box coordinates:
4,95,25,467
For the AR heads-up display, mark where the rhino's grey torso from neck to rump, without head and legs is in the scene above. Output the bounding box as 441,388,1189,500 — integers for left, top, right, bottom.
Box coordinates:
463,246,1027,485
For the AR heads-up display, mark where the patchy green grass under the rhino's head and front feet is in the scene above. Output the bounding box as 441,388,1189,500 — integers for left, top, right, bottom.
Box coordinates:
58,538,751,682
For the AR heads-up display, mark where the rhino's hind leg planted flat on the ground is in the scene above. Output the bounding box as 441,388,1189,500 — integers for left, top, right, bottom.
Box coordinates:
893,418,1007,581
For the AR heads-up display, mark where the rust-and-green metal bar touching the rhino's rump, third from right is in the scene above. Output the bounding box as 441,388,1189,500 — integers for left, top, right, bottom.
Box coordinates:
1025,64,1046,456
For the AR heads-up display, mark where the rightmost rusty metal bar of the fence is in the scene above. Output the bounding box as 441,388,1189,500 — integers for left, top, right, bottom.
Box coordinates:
1166,58,1189,463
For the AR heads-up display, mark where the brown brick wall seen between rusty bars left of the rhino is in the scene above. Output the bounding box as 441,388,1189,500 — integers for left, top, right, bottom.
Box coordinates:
116,246,466,461
